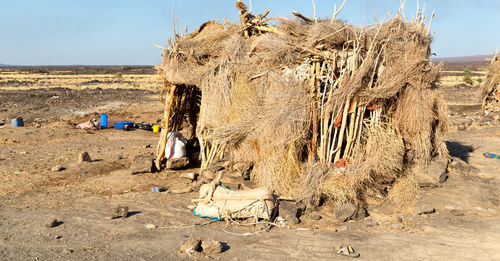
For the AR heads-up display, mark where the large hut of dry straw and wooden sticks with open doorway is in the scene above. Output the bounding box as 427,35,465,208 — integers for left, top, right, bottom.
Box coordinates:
157,1,447,205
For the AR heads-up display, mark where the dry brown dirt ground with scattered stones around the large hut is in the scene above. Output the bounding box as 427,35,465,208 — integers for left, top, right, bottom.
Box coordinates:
0,67,500,260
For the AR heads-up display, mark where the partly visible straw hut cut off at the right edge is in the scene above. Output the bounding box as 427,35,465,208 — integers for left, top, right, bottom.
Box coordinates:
481,50,500,111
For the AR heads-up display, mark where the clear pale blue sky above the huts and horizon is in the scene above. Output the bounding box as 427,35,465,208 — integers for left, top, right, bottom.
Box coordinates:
0,0,500,65
